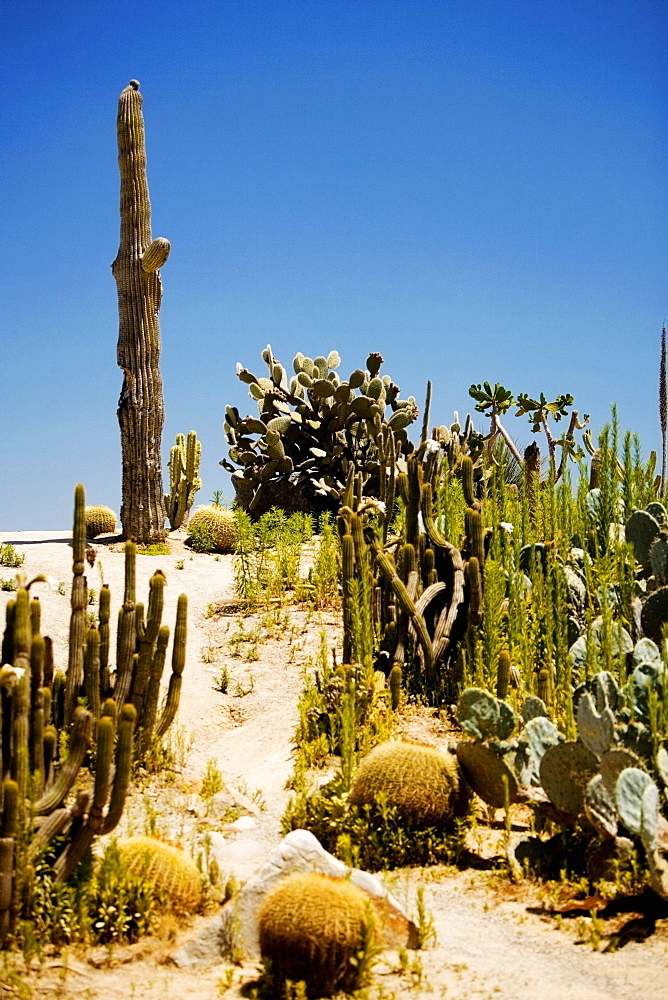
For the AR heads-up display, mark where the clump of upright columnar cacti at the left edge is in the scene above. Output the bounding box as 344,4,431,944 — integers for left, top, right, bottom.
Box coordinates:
0,486,187,939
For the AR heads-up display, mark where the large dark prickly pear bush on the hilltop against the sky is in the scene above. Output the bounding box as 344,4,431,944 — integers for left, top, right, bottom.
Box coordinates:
221,347,418,517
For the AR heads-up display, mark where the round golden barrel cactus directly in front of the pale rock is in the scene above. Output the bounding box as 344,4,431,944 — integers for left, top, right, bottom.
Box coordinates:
258,872,372,997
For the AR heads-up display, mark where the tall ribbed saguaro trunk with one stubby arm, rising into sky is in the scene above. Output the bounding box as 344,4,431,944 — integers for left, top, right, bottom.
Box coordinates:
111,80,169,543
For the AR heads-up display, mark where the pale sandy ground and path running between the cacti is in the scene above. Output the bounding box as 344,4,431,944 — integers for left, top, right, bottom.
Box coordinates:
0,531,668,1000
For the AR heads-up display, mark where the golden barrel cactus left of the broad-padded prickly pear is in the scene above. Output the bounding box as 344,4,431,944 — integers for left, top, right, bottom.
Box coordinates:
350,740,467,827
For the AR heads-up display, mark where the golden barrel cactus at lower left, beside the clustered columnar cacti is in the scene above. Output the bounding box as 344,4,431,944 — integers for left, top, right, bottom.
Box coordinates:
118,837,202,913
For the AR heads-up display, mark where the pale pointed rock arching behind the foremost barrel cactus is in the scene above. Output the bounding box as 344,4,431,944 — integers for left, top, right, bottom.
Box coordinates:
168,830,418,968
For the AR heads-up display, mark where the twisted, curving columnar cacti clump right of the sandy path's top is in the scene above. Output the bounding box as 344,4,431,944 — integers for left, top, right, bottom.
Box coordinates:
338,438,485,706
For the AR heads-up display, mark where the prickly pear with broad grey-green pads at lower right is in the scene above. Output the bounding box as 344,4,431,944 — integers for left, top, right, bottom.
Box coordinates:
457,668,668,899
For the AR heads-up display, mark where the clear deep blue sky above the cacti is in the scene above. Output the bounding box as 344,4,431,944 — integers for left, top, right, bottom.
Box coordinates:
0,0,668,530
